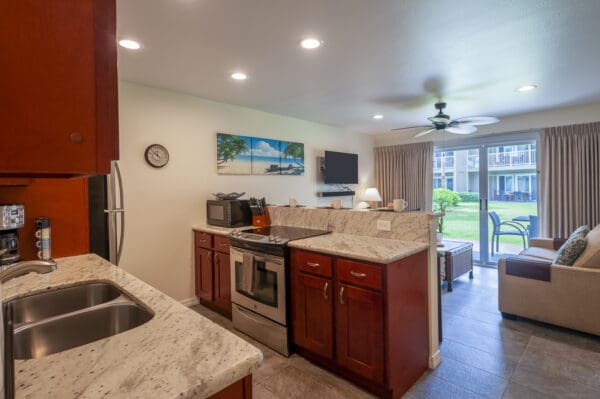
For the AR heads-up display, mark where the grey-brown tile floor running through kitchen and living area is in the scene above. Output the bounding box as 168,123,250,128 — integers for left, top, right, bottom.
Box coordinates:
193,267,600,399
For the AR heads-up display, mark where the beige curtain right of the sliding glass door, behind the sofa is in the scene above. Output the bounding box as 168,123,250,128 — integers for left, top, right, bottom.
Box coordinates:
539,122,600,237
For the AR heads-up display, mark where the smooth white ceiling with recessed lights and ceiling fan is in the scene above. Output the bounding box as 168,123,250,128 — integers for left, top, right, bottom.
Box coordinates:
117,0,600,133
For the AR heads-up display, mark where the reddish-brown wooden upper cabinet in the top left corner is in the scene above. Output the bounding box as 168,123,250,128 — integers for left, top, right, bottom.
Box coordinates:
0,0,118,176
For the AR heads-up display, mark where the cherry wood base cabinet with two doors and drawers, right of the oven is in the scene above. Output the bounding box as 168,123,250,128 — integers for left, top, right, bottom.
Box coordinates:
291,249,429,398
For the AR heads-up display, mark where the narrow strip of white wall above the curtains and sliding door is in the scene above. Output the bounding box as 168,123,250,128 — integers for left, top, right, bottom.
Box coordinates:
374,103,600,147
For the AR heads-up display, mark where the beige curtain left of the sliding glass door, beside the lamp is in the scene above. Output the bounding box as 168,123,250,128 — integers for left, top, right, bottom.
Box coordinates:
375,142,433,211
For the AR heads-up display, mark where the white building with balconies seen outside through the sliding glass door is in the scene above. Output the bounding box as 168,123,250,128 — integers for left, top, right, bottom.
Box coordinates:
433,143,537,201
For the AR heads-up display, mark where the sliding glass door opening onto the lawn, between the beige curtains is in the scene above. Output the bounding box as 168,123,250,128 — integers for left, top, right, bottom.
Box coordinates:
433,140,538,266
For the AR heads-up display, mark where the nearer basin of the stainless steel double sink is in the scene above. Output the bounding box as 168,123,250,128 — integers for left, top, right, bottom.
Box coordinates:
13,302,152,359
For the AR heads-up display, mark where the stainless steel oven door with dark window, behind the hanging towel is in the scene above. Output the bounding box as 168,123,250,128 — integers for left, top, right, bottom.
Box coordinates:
230,247,287,326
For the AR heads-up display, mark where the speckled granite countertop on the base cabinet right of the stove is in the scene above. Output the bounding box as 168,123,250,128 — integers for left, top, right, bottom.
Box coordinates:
288,233,429,264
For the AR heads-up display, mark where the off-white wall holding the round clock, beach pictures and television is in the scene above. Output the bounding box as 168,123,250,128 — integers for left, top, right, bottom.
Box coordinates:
119,82,373,300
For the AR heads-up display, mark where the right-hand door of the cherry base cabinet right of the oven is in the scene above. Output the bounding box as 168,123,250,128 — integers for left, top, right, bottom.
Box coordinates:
335,283,384,383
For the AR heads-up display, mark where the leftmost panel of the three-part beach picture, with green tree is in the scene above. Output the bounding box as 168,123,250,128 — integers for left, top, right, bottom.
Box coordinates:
217,133,252,175
